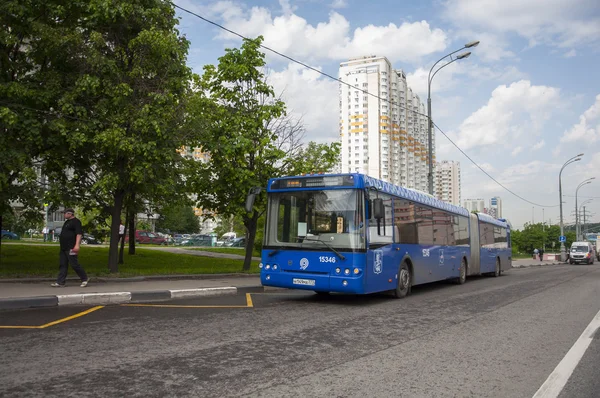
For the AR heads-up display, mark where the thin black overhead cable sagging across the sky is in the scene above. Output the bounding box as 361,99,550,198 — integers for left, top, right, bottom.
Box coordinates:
172,3,559,207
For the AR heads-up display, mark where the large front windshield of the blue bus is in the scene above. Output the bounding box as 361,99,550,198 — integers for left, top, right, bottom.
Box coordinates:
265,189,365,249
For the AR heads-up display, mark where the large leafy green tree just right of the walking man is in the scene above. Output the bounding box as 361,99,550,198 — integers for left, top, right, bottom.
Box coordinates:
37,0,192,272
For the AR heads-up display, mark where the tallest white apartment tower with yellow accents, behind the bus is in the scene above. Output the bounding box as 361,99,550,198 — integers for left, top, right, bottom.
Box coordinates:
339,56,435,192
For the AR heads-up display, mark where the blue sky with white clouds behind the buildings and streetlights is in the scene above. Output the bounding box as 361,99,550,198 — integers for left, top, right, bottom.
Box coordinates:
174,0,600,229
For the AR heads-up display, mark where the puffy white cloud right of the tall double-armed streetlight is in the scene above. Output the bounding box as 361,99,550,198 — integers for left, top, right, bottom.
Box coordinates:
457,80,560,150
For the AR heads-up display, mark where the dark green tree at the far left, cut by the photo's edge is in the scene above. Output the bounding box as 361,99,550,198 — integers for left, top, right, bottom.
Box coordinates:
0,0,88,243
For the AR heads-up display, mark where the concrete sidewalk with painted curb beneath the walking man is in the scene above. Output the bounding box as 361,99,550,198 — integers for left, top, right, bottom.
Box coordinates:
0,275,264,310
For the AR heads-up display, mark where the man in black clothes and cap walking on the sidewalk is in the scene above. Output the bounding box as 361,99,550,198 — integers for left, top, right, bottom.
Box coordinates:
50,208,88,287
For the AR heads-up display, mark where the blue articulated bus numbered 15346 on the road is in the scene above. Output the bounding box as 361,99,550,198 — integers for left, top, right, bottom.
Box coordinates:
253,174,511,297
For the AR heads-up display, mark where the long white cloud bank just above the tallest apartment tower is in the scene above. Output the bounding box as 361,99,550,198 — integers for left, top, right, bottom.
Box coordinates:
212,0,447,63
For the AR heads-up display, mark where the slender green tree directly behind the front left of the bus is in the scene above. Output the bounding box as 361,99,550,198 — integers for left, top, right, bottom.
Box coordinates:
192,38,285,270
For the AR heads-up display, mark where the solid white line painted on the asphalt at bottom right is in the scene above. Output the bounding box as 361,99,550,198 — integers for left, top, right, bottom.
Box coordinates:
533,311,600,398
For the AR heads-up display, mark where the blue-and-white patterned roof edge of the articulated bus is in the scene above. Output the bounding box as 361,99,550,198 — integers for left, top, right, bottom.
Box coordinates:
267,173,474,218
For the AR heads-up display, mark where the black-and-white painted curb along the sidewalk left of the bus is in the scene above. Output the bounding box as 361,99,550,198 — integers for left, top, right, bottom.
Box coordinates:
0,286,264,310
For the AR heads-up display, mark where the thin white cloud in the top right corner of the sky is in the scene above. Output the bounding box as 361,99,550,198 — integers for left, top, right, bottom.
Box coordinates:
444,0,600,48
